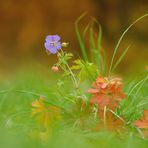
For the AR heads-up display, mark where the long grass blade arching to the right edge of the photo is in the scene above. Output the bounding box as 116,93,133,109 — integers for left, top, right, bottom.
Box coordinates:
109,13,148,76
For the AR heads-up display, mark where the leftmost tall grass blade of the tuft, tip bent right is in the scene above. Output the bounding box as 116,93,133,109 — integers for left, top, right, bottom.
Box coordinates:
75,12,88,61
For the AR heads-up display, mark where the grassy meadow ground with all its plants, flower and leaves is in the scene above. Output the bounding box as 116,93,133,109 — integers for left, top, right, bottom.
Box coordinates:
0,14,148,148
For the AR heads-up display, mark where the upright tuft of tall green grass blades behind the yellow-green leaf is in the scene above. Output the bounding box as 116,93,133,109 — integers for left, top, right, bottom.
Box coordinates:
75,13,106,74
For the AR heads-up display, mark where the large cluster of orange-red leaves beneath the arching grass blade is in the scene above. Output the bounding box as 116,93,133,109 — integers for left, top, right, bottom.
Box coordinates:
88,76,125,110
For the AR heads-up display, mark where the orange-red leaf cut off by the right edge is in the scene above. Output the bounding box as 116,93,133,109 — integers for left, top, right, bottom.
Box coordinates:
134,110,148,129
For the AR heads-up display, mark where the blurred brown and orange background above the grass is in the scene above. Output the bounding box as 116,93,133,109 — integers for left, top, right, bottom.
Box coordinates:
0,0,148,79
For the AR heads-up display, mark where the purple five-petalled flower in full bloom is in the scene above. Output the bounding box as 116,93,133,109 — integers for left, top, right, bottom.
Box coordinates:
44,35,62,54
